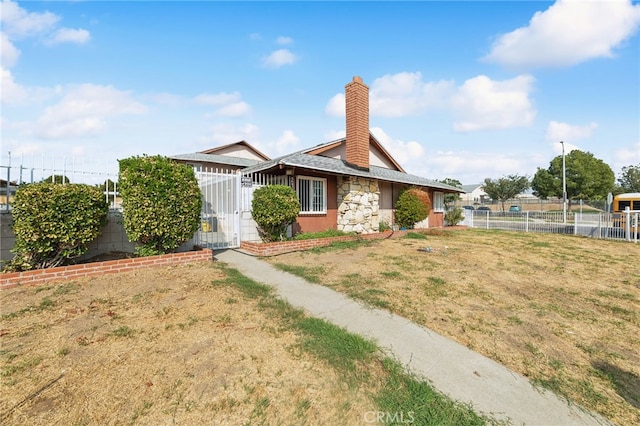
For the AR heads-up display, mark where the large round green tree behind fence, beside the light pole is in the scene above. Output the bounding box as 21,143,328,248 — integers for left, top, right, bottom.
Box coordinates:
531,149,615,206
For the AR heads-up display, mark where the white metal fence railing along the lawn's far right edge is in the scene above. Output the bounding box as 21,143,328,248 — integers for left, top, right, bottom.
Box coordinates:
461,210,640,243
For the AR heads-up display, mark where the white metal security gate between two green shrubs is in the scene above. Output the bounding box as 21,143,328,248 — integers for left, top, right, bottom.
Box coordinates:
194,170,241,248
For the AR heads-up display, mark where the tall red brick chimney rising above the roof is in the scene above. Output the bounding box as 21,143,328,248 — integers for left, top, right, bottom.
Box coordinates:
344,76,369,170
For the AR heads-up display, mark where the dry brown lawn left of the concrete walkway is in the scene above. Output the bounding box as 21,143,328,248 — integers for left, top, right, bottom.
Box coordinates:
0,264,375,425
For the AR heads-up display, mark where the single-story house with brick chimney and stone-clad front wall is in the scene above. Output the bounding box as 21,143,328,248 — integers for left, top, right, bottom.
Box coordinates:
172,77,463,233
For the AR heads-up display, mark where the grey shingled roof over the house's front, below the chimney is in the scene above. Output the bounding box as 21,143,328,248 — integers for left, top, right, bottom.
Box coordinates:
242,150,462,192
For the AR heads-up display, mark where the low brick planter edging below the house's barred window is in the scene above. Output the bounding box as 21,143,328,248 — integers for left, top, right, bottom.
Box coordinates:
240,231,407,256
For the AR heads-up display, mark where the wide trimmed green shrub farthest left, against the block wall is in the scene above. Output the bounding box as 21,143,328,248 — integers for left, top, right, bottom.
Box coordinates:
7,182,109,271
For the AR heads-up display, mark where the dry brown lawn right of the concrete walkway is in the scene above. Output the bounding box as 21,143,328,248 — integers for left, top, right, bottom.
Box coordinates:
269,229,640,425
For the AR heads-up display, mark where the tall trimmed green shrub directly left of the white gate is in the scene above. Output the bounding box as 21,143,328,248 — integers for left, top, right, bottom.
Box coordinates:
118,155,202,256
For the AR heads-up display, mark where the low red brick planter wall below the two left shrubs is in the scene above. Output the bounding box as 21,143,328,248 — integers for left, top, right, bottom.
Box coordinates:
0,249,213,289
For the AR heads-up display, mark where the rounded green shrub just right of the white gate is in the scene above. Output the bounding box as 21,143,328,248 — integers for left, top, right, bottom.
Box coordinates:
251,185,300,242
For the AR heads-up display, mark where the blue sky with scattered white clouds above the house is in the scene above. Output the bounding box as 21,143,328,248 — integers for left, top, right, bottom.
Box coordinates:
0,0,640,184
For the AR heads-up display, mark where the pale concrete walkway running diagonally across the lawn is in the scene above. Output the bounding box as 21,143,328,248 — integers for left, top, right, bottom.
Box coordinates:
215,250,611,426
